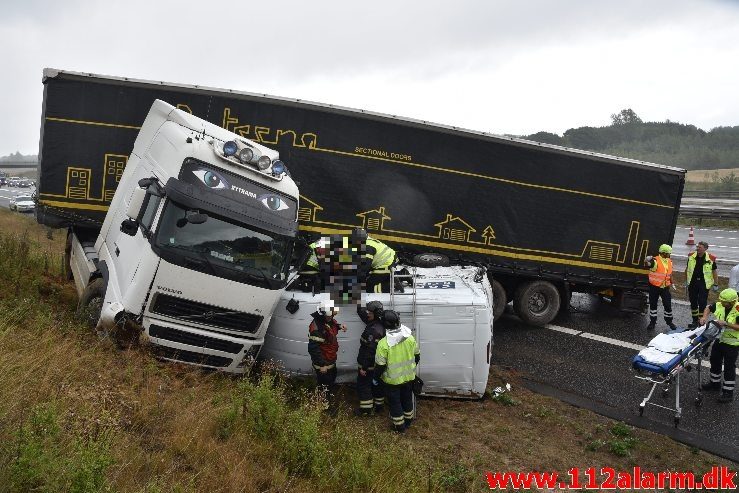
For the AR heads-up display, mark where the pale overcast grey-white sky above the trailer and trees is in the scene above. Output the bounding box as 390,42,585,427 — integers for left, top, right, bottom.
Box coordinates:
0,0,739,156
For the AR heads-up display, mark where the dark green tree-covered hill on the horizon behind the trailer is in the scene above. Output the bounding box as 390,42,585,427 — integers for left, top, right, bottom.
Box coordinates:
523,108,739,170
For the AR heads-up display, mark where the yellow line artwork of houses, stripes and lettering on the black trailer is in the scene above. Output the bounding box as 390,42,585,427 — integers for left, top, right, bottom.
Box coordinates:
40,104,674,273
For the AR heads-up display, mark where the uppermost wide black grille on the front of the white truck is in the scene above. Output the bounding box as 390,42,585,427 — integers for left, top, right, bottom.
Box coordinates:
150,293,263,334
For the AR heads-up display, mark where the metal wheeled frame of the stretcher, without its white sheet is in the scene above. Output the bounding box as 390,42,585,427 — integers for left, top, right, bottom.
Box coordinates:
632,320,721,428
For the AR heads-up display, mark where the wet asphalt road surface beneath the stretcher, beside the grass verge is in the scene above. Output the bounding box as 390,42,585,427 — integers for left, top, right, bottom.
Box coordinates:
493,294,739,462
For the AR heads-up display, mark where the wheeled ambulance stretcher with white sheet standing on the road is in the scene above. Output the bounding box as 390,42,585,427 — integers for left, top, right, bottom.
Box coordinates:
631,321,721,427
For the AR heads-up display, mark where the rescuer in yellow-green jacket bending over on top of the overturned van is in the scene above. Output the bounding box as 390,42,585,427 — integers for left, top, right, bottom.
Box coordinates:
350,228,397,293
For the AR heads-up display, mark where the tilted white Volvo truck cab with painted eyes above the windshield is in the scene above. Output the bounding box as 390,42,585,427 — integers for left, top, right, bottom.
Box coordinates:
68,100,298,373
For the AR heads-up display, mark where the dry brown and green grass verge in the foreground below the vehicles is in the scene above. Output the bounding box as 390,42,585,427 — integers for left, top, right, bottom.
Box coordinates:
0,211,736,492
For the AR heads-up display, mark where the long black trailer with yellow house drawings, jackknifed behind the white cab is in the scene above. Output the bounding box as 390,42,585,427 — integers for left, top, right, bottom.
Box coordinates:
37,69,685,324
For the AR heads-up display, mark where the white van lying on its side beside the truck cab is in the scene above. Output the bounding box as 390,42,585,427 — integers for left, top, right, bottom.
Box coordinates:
260,266,493,398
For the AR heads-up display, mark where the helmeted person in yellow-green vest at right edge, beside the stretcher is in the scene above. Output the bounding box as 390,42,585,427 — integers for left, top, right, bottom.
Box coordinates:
700,288,739,402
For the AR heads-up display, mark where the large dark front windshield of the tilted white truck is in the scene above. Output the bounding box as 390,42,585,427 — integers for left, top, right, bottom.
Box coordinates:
154,201,292,289
